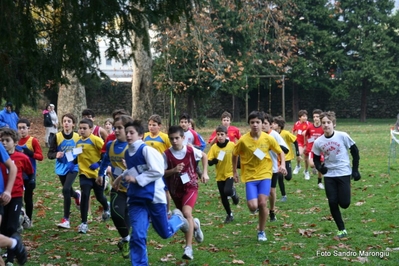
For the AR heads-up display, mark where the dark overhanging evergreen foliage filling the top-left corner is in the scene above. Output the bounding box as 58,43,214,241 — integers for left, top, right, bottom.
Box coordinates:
0,0,192,117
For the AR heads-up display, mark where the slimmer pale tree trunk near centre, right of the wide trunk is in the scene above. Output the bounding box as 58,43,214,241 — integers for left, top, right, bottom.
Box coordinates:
132,27,156,121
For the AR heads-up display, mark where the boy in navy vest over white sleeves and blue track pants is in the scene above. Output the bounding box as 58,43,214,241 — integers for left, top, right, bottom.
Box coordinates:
111,120,188,265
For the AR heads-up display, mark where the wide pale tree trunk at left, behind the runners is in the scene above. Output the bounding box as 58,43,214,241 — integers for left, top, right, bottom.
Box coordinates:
57,72,87,127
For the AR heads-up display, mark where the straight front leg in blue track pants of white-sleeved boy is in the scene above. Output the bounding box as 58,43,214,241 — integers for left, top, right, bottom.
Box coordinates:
128,202,149,265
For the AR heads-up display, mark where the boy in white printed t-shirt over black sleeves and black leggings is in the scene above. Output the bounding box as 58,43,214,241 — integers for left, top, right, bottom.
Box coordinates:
312,111,360,238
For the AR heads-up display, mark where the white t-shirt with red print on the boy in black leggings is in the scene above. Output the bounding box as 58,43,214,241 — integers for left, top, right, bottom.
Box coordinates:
312,131,355,177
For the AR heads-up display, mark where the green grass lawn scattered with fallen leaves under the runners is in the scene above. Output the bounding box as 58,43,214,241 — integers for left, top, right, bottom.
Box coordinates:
24,120,399,265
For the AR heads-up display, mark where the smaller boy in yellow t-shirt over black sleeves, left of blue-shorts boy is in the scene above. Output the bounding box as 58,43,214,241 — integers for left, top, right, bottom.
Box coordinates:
208,126,239,224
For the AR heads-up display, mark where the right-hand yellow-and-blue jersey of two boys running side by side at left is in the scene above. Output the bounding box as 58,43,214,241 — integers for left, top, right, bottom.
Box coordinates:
76,134,104,178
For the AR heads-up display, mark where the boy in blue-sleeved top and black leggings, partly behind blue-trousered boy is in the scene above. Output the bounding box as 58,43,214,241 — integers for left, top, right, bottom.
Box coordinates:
97,115,133,258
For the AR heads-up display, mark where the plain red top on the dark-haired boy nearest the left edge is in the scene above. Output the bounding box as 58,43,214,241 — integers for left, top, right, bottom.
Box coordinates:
0,151,33,198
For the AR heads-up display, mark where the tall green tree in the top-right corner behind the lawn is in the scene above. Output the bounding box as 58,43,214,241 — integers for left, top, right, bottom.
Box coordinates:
334,0,399,122
